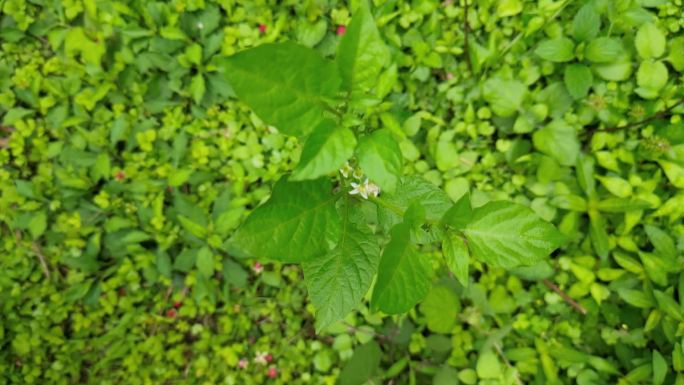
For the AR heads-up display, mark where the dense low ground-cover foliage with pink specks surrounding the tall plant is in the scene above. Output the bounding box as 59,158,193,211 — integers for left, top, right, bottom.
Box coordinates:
0,0,684,385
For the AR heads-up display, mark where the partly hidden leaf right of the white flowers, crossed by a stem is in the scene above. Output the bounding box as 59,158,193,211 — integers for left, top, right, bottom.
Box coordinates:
378,176,451,232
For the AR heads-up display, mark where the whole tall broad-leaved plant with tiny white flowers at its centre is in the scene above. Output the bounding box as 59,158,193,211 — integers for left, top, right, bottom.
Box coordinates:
219,2,564,330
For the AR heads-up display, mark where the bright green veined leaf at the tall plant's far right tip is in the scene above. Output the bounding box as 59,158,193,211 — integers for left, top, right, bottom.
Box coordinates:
463,201,564,268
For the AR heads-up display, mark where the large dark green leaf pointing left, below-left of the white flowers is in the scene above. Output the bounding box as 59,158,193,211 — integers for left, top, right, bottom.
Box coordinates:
229,177,341,262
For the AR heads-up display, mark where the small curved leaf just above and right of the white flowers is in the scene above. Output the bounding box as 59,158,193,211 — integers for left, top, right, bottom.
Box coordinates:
356,129,403,194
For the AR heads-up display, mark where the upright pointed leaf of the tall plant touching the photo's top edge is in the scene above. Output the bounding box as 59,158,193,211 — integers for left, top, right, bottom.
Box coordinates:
336,0,390,92
